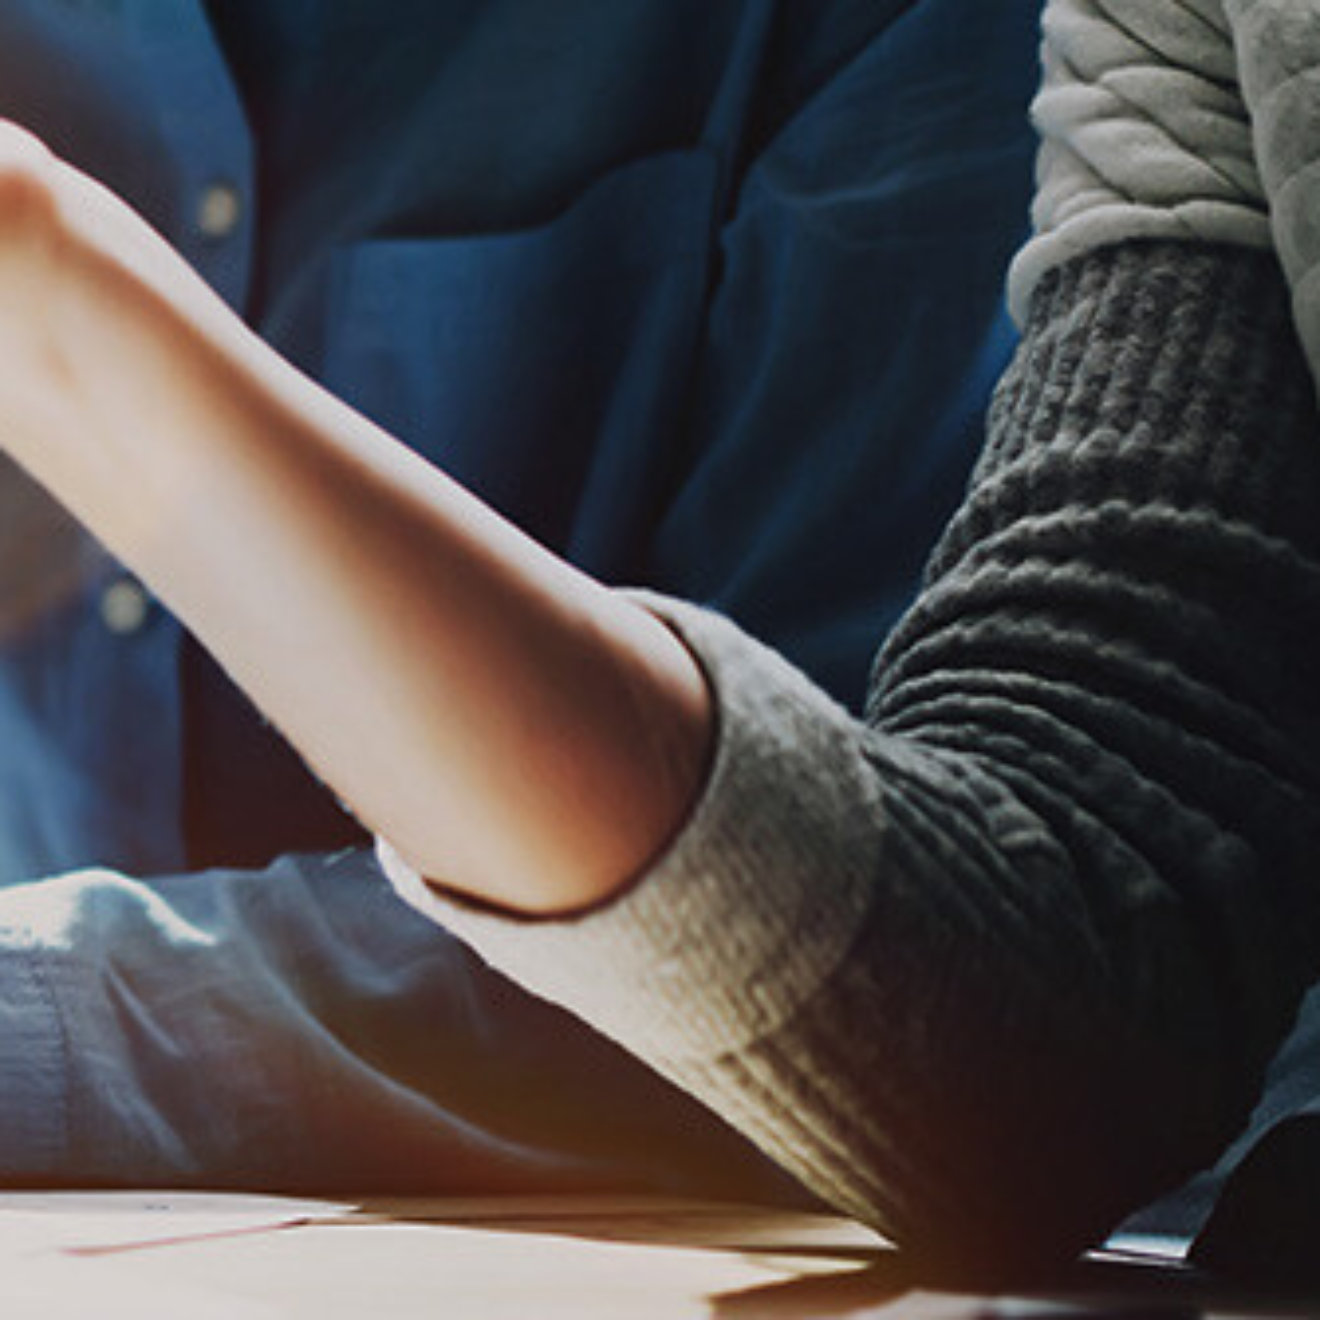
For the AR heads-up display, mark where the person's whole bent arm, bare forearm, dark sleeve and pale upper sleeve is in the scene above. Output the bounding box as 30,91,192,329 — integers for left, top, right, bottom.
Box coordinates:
0,0,1320,1265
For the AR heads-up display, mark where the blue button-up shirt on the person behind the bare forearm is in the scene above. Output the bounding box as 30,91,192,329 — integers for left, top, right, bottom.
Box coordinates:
0,0,1039,1189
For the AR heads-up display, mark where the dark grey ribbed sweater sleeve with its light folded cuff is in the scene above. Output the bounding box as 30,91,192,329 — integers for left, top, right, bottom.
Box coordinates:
393,242,1320,1263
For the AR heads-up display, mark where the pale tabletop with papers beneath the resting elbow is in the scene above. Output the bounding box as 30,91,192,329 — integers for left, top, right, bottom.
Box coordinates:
0,1193,1317,1320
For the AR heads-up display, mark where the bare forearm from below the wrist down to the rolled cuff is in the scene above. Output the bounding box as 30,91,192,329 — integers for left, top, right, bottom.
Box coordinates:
0,131,709,909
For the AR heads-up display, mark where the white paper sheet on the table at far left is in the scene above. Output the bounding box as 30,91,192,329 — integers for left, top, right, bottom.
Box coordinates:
0,1191,354,1259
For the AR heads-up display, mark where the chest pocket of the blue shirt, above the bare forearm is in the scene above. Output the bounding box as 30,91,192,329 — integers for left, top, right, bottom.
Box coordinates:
323,149,718,576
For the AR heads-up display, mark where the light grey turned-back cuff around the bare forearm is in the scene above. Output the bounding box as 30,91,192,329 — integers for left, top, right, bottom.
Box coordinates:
381,593,878,1060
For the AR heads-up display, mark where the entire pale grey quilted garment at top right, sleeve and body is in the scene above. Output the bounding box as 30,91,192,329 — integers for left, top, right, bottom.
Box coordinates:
1008,0,1320,381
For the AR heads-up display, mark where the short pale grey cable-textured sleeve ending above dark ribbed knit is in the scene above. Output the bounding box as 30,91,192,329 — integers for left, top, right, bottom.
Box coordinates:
1008,0,1272,321
